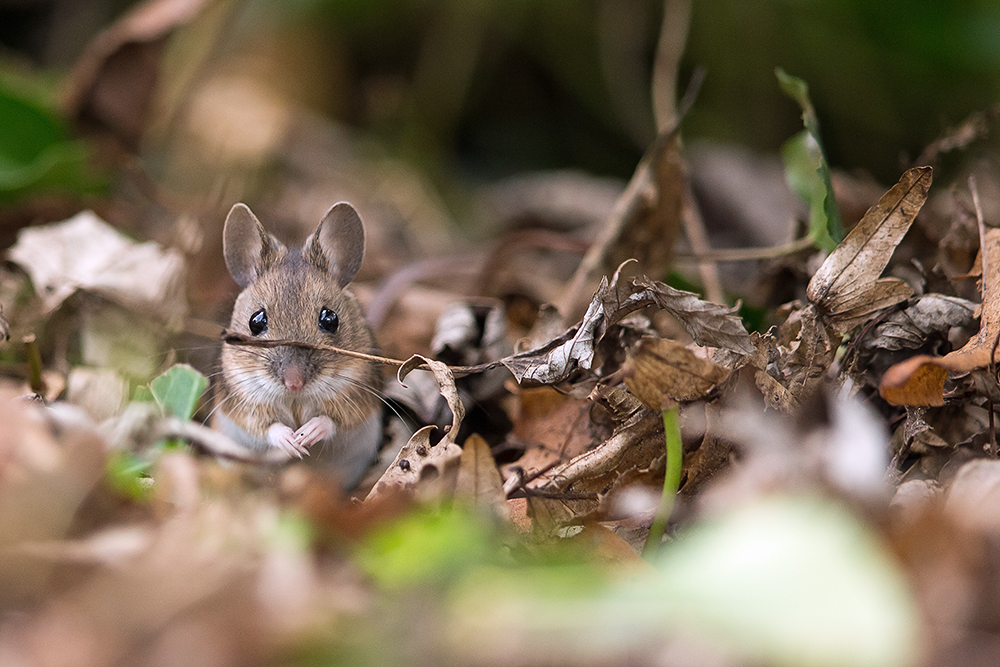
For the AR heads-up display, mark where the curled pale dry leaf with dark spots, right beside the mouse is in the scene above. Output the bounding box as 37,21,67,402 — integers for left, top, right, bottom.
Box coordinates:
365,355,465,502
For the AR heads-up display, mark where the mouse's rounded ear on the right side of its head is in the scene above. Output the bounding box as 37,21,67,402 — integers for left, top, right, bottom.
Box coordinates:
303,201,365,287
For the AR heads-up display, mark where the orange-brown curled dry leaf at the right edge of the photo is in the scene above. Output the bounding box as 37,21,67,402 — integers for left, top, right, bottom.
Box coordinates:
879,229,1000,405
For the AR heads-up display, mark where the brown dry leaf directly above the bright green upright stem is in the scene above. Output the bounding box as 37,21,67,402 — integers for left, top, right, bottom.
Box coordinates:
625,338,729,410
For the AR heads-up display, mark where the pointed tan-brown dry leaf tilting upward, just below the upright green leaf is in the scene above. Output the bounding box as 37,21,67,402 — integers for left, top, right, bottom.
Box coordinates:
806,167,932,332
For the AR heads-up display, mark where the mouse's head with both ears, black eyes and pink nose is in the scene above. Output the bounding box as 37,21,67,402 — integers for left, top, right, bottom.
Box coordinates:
223,202,374,400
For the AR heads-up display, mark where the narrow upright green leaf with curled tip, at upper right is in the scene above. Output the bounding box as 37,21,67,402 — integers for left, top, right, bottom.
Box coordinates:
775,67,844,252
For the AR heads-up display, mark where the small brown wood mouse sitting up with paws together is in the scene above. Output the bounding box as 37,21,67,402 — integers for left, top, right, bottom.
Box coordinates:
213,202,382,488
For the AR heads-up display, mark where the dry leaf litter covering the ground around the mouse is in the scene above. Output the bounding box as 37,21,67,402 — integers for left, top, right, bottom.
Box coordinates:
0,6,1000,667
